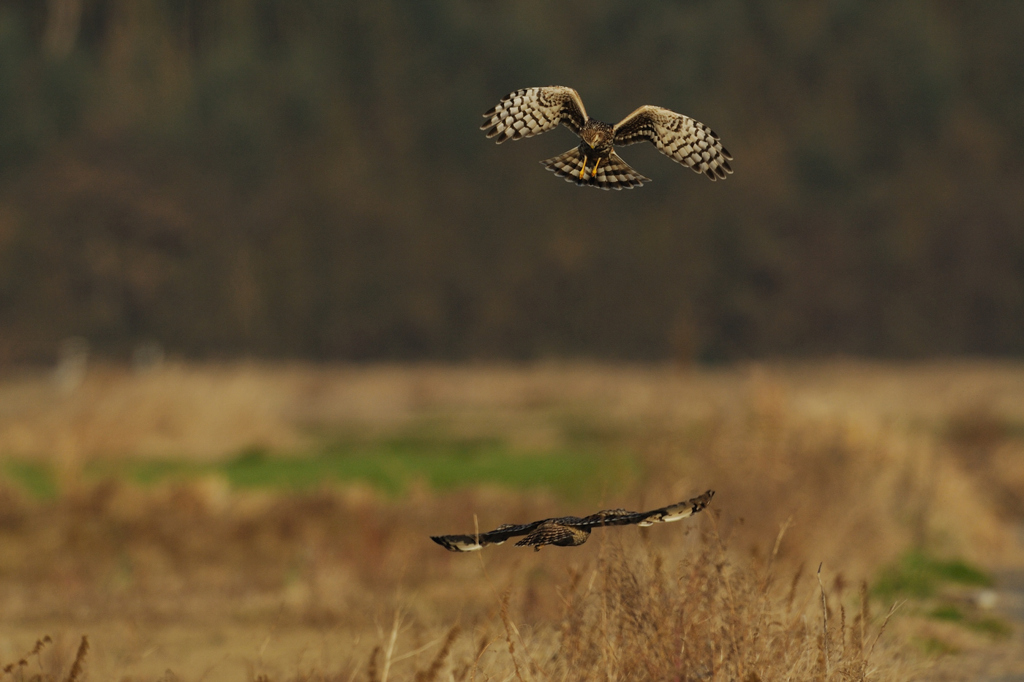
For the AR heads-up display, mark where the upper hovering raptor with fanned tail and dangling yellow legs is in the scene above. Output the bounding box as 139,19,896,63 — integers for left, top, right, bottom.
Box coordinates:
480,85,732,189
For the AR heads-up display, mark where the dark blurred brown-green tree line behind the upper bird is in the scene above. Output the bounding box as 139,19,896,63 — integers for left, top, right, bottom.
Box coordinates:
0,0,1024,363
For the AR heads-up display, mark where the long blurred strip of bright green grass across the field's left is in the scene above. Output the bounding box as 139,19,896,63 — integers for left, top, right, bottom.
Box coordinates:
0,433,639,499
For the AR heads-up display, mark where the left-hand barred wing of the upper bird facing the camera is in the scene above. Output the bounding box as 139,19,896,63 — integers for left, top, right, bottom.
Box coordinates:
480,85,587,144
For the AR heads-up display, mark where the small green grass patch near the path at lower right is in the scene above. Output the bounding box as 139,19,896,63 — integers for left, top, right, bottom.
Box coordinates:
871,551,992,600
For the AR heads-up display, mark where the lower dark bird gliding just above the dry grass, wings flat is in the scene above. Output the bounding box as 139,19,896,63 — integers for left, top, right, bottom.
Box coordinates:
430,491,715,552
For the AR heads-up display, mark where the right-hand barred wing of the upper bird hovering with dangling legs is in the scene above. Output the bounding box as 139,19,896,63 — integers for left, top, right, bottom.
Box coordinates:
614,105,732,180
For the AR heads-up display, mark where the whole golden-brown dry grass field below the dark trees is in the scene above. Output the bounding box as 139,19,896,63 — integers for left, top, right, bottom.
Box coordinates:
0,361,1024,682
